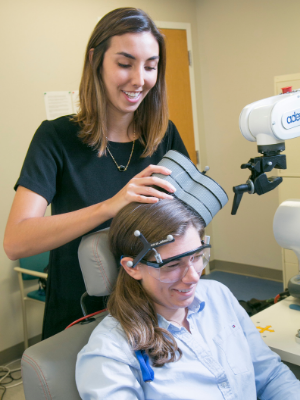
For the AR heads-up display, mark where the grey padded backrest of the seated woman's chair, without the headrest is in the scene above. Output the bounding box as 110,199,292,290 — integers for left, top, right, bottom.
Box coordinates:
21,312,108,400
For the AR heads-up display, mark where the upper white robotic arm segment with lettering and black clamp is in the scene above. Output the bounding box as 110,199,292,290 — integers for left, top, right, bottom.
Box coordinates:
231,89,300,215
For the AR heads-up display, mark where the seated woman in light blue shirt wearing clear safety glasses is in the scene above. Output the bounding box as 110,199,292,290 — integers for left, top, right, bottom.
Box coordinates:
76,199,300,400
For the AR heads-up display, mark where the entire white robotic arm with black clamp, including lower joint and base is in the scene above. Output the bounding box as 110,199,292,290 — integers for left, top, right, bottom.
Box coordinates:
231,88,300,300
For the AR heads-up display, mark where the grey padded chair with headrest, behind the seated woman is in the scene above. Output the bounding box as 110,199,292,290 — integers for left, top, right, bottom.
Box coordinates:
21,229,112,400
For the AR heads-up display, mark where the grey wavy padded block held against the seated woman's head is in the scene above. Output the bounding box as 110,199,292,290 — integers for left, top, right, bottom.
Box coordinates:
153,150,228,226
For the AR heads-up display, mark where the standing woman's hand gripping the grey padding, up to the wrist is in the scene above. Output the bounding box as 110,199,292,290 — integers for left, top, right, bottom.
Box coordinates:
106,165,176,218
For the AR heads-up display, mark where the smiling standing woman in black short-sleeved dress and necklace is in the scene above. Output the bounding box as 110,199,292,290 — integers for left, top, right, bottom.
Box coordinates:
4,8,187,338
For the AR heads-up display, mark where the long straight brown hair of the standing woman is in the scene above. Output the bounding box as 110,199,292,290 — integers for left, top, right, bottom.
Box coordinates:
73,7,168,157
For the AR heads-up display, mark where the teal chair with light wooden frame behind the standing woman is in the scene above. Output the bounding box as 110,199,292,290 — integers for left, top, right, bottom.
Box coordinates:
14,251,50,349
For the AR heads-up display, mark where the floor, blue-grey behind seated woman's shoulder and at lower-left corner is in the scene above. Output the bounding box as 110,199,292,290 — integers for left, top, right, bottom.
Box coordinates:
0,271,283,400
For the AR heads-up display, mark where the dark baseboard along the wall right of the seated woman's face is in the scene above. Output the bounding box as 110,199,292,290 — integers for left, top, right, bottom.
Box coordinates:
209,260,283,282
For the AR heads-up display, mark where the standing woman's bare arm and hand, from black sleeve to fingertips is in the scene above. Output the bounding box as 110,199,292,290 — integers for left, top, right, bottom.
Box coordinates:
4,165,175,260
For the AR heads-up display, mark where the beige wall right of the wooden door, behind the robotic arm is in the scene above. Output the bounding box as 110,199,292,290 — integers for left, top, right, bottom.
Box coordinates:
197,0,300,270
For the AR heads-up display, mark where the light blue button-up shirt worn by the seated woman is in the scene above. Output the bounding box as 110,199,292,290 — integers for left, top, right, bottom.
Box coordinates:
76,280,300,400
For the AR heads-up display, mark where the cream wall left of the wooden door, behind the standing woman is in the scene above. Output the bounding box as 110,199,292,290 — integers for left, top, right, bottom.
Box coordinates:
0,0,205,351
